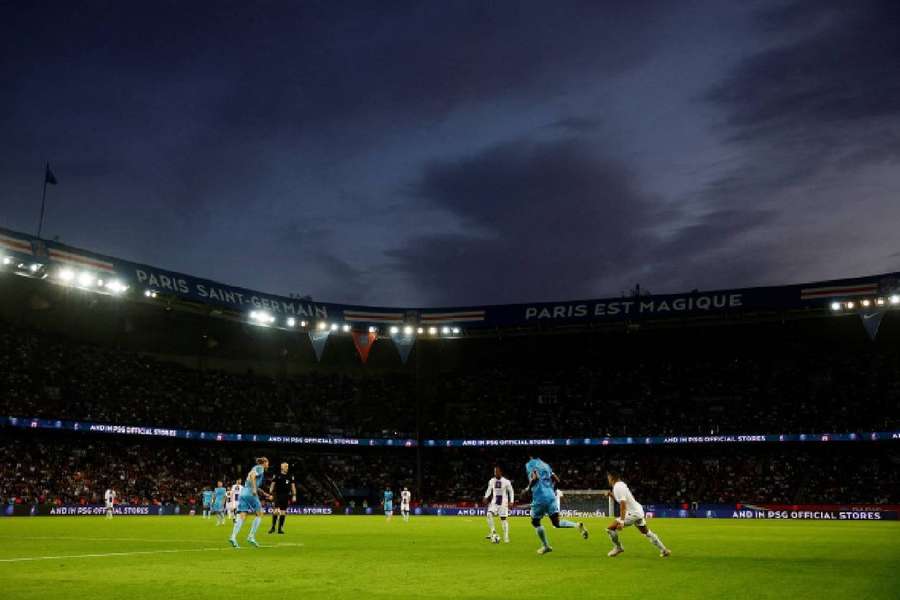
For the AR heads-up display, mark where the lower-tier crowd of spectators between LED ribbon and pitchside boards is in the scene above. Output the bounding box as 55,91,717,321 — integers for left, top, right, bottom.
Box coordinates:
0,431,900,506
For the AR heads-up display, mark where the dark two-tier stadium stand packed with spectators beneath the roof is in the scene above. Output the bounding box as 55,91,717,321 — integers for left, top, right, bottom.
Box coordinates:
0,244,900,506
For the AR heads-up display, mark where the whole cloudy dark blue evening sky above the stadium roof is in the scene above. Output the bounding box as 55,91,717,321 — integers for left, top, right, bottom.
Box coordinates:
0,0,900,305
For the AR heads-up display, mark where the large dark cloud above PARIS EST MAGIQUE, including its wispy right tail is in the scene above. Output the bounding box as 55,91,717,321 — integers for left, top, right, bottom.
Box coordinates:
388,138,771,304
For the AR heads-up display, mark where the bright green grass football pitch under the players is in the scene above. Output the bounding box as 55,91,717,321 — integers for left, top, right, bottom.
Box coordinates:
0,516,900,600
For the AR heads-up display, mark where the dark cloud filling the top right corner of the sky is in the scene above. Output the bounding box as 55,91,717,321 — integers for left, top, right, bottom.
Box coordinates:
707,0,900,162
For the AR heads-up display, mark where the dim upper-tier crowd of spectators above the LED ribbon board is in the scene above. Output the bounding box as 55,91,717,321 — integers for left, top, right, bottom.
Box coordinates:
0,323,900,439
